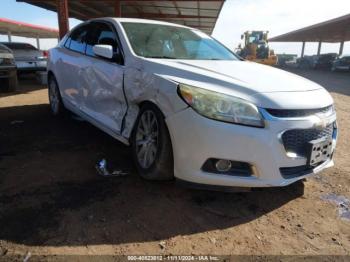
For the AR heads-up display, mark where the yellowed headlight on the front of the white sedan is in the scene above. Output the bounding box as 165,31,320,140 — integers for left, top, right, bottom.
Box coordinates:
179,84,264,127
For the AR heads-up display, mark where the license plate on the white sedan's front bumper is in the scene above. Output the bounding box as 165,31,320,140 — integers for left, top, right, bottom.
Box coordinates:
308,137,333,166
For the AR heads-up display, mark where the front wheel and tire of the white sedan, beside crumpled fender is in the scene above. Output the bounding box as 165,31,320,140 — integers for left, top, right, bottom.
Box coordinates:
132,104,174,180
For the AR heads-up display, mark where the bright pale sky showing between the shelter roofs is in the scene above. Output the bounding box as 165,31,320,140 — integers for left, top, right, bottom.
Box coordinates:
0,0,350,55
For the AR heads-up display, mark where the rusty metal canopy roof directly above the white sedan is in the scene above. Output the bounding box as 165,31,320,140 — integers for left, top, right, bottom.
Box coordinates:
17,0,225,34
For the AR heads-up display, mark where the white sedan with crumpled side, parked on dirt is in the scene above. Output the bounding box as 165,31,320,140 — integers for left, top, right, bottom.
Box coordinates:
48,18,337,187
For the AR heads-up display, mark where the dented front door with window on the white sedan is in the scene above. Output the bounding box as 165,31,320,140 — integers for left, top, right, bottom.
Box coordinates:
82,21,127,133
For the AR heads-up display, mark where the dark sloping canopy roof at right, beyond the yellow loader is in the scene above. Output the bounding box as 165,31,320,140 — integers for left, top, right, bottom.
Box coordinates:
269,14,350,43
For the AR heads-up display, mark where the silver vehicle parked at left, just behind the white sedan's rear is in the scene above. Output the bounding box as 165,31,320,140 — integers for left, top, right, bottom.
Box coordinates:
1,42,47,73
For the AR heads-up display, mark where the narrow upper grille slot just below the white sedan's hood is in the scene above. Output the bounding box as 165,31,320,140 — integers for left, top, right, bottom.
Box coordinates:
266,105,333,118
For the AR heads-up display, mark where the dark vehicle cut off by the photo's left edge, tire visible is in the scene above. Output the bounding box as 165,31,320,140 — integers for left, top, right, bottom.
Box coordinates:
0,44,17,91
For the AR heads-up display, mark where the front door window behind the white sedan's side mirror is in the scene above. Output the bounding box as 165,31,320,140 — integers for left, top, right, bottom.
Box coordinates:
86,22,120,59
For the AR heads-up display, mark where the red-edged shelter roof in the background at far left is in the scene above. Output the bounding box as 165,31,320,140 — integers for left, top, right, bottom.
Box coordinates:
0,18,58,38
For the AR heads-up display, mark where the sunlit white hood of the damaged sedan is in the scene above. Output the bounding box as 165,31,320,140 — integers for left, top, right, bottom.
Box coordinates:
139,59,333,109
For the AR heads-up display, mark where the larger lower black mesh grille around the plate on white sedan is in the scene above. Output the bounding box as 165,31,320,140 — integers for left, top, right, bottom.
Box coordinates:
282,123,334,156
